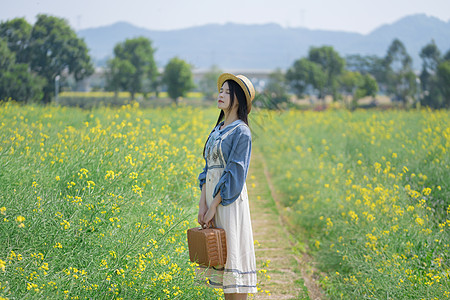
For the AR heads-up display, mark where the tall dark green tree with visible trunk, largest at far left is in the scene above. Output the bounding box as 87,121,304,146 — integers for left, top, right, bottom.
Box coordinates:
28,15,94,103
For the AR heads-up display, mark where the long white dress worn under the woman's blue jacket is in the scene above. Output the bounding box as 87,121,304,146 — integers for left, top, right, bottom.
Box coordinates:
197,122,257,293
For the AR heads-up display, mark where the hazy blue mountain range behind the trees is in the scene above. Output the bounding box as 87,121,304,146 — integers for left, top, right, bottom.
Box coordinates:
78,14,450,69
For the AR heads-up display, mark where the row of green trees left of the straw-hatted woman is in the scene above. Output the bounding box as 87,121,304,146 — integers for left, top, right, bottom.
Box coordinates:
0,14,194,103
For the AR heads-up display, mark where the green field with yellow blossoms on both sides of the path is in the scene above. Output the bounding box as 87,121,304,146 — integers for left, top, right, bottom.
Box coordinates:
0,103,450,299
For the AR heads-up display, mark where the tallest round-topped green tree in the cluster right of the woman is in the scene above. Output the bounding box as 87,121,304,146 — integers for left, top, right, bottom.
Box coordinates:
308,46,345,100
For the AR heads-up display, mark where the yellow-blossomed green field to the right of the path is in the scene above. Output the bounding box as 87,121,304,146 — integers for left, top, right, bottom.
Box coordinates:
254,110,450,299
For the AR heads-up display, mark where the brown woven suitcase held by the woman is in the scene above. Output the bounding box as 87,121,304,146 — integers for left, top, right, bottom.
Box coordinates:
187,227,227,267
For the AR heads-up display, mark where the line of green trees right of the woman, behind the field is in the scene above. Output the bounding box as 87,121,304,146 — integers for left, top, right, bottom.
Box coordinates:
265,39,450,108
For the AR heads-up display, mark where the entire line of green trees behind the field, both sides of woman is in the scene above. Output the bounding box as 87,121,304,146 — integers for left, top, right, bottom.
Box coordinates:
0,15,450,108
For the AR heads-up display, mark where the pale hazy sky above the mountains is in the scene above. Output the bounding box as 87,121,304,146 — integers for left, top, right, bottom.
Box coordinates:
0,0,450,34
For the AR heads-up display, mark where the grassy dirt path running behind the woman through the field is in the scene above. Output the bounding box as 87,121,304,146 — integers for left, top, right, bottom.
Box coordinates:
247,150,324,300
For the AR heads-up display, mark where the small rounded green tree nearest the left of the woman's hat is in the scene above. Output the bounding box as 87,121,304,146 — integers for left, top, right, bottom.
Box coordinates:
163,57,194,104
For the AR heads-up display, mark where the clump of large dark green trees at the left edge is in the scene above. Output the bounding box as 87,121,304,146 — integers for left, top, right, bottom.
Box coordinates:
0,15,94,103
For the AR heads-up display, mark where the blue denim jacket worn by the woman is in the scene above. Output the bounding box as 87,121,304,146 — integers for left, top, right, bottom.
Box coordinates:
198,120,252,205
